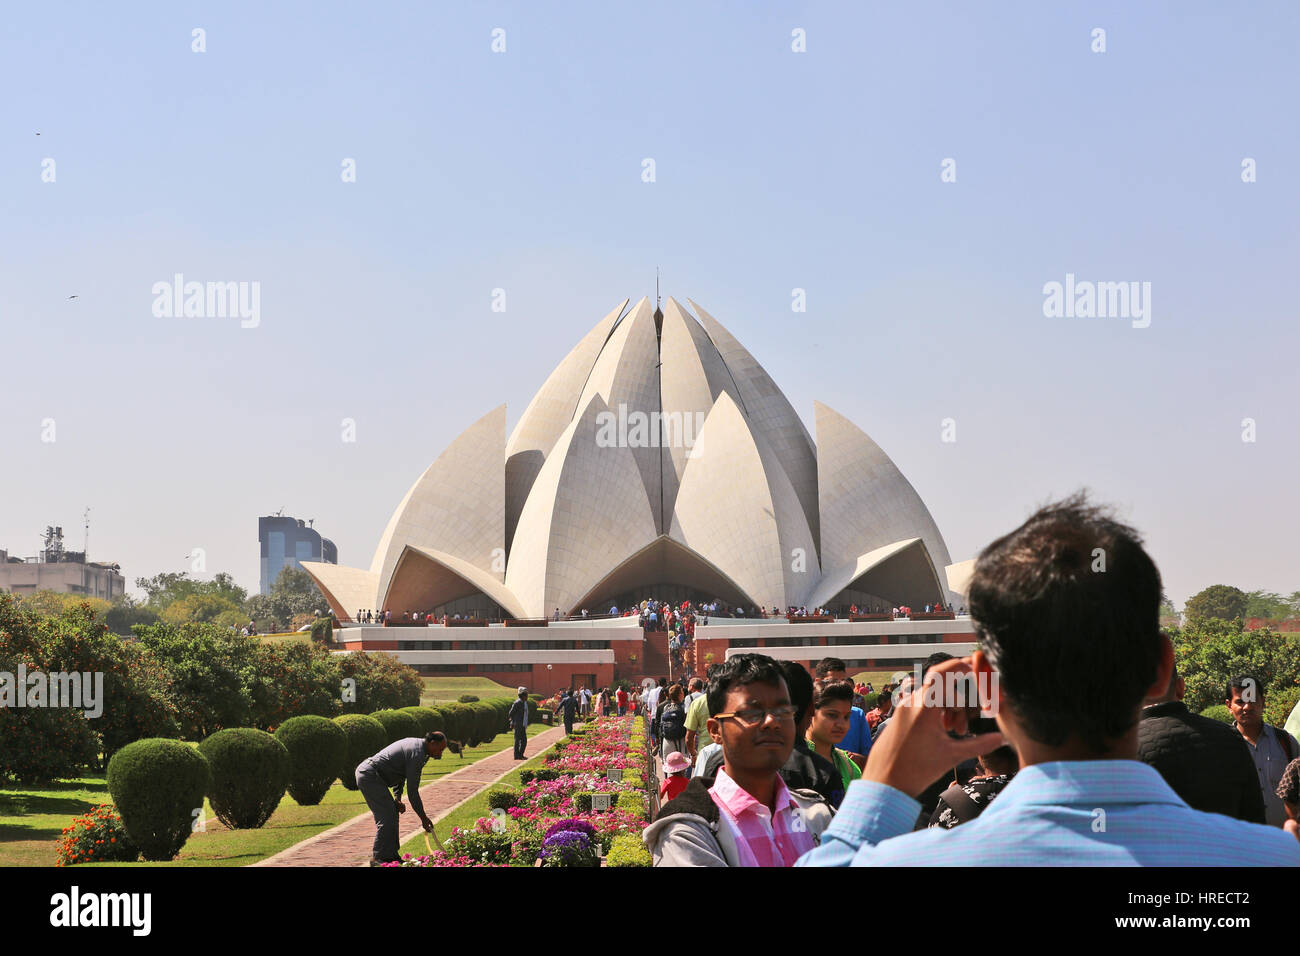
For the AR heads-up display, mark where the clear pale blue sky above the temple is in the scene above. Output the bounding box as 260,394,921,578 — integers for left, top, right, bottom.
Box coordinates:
0,0,1300,605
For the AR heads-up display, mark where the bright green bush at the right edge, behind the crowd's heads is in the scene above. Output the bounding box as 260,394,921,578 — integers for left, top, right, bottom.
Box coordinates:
1169,618,1300,713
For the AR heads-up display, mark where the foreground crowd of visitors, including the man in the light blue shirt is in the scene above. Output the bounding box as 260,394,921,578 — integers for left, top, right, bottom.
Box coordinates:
631,496,1300,866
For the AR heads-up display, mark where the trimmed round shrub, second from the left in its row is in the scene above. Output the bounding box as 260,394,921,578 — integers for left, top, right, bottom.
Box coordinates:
199,727,290,830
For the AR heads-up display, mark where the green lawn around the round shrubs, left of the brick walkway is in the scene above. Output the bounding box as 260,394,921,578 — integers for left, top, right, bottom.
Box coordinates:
0,723,550,868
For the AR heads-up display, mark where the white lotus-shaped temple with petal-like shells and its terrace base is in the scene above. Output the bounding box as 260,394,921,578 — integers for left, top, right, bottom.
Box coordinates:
303,297,972,692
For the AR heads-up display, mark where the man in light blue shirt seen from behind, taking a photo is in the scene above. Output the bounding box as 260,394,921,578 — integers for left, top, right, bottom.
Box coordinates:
798,496,1300,866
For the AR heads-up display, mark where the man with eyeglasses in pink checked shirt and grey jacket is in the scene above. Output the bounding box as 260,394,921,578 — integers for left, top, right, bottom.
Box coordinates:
642,654,831,866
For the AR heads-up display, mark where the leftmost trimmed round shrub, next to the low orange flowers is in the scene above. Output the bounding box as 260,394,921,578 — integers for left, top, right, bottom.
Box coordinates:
108,737,212,861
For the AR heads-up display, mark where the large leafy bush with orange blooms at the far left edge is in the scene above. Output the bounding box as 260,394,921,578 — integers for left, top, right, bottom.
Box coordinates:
0,594,178,764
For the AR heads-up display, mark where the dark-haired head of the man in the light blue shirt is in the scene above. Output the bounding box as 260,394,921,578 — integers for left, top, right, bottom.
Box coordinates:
970,494,1161,754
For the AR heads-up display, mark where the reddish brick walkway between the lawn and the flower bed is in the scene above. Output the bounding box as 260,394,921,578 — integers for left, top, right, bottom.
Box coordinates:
251,724,577,866
